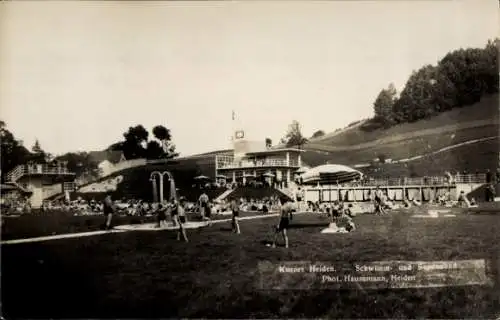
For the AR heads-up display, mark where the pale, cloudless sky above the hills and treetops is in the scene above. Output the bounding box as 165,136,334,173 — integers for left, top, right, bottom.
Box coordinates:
0,0,499,156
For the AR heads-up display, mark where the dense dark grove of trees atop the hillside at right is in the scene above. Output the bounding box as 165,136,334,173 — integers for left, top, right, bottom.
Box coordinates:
361,39,500,131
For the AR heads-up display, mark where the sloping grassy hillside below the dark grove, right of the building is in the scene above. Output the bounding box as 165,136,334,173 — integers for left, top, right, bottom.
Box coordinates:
303,94,500,175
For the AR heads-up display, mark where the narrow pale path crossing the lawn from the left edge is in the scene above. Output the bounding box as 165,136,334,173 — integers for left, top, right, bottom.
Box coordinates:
0,212,292,245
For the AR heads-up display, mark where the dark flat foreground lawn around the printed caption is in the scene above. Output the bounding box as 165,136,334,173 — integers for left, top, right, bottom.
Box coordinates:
2,208,500,318
